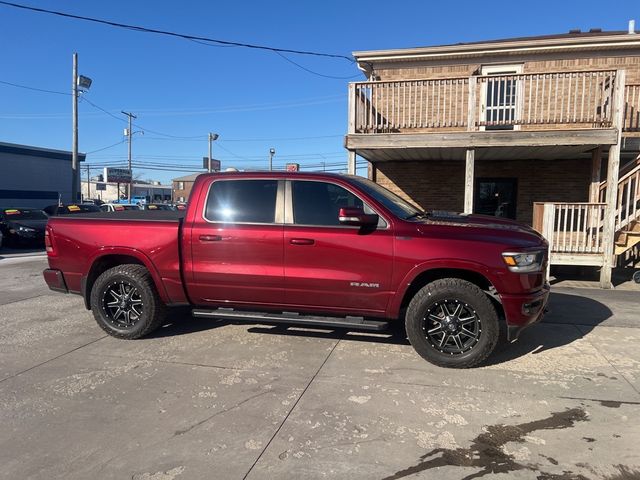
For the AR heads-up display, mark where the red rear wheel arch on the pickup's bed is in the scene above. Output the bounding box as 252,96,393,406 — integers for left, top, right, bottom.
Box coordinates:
81,249,168,310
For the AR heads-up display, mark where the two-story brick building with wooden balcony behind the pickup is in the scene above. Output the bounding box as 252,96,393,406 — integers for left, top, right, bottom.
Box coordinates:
345,22,640,288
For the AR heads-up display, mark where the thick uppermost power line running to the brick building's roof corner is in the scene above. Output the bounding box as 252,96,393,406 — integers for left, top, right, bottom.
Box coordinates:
0,1,354,64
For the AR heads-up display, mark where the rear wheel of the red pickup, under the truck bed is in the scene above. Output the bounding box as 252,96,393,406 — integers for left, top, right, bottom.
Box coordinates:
90,264,166,340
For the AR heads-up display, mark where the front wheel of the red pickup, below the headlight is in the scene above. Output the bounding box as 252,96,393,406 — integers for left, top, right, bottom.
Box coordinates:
405,278,500,368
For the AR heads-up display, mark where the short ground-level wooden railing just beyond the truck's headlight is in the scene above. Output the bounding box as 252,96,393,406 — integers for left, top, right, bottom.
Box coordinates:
533,203,606,261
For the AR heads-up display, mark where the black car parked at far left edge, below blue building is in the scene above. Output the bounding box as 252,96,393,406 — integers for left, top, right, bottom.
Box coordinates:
0,208,48,247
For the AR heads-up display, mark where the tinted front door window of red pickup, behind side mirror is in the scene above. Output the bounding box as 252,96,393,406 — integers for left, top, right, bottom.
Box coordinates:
292,181,368,226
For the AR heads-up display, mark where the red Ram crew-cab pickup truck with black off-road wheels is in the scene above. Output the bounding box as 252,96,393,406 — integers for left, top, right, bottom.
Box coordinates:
44,172,549,367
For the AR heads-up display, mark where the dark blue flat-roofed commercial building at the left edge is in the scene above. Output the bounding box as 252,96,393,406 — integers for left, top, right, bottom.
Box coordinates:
0,142,85,208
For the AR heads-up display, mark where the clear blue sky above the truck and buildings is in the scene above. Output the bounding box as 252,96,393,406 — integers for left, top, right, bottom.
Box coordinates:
0,0,640,182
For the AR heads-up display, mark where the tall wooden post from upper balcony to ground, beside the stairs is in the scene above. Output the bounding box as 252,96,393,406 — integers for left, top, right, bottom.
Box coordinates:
600,70,625,288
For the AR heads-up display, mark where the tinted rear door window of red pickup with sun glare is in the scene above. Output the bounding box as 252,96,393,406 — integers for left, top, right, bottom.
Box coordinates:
205,180,278,223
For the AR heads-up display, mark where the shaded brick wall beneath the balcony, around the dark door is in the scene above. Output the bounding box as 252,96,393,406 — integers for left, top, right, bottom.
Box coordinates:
376,160,591,224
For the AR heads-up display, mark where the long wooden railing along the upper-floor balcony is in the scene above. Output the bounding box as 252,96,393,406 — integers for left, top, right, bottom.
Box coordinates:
349,70,620,133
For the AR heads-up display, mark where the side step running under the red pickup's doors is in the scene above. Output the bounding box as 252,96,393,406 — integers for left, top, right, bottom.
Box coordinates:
191,308,389,332
